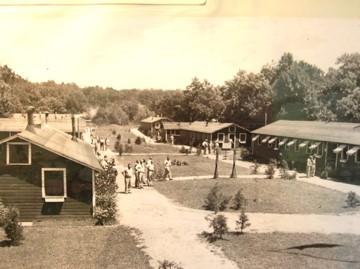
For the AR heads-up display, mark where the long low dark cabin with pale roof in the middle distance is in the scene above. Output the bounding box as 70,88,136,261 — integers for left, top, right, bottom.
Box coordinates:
163,121,250,147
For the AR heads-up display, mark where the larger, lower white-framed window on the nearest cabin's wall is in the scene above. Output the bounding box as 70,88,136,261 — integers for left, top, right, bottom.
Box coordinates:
41,168,67,202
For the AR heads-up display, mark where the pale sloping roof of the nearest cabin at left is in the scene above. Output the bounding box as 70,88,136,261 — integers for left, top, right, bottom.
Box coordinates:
0,126,102,170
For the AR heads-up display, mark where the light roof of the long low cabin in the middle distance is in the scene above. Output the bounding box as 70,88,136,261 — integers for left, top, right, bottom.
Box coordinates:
163,121,248,134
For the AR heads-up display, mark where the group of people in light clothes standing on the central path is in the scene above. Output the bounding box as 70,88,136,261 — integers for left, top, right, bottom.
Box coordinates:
122,157,172,193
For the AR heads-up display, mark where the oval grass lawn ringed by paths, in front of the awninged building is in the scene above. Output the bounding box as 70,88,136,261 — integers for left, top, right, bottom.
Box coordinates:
155,179,359,214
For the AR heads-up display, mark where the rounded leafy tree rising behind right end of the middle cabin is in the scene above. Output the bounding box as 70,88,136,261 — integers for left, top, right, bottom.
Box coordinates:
221,71,271,126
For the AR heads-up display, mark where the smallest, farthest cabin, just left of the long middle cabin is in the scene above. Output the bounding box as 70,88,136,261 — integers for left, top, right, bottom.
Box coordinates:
139,117,170,141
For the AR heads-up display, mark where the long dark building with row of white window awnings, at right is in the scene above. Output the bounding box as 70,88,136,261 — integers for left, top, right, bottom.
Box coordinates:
251,120,360,183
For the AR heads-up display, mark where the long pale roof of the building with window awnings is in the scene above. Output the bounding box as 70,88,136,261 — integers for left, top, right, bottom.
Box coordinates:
252,120,360,145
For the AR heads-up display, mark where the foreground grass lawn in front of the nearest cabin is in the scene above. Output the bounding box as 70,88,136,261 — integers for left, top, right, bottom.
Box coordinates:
0,221,150,269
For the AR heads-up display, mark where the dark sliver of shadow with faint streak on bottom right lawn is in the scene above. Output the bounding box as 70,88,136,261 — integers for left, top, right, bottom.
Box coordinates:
269,243,360,264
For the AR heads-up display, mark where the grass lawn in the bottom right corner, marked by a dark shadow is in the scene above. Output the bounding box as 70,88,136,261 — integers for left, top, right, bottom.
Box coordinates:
214,233,360,269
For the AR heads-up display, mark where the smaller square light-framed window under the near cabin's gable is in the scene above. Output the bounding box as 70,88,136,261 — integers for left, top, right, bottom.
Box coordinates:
6,142,31,165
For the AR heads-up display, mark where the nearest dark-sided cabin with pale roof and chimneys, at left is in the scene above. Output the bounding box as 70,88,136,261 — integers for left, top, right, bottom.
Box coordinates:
0,108,102,221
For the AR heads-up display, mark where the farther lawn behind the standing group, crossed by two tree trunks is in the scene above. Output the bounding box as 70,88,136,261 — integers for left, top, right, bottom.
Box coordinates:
119,154,250,177
